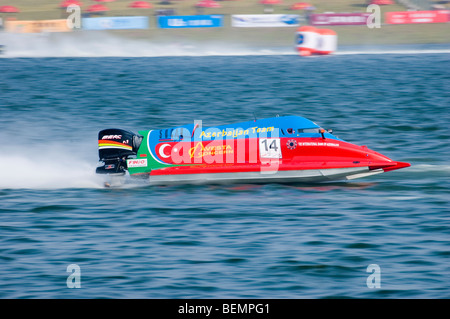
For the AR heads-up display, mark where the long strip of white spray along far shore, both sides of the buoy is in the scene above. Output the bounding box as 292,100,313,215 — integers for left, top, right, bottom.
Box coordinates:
0,32,450,58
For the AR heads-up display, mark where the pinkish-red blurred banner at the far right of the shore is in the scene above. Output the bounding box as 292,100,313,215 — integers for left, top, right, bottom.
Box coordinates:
386,10,450,24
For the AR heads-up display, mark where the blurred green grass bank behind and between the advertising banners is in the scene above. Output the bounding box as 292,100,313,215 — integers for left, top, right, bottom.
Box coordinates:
0,0,450,46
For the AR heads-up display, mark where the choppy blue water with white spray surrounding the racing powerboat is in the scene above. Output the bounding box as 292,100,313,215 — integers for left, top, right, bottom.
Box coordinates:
0,52,450,298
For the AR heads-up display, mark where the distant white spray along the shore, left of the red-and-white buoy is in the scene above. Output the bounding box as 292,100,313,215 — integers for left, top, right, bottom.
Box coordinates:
0,32,295,58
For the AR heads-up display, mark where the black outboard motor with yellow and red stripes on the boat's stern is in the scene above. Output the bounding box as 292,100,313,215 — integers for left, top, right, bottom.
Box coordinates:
96,129,143,175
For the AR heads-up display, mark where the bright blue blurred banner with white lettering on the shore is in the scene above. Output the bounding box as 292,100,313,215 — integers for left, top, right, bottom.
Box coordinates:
158,14,223,29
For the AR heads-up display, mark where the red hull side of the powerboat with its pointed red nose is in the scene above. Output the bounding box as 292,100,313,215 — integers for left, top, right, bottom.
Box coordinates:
146,138,410,183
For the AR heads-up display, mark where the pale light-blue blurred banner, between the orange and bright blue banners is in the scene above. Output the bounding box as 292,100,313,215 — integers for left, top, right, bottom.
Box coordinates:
81,16,149,30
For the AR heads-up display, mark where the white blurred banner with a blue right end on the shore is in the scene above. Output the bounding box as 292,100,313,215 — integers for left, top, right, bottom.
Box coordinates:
231,14,300,28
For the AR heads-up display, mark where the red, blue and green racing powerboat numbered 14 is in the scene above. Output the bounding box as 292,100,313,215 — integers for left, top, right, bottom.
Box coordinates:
96,116,410,185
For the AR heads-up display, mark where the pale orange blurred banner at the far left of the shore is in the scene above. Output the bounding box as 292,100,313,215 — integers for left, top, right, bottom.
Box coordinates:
5,19,72,33
